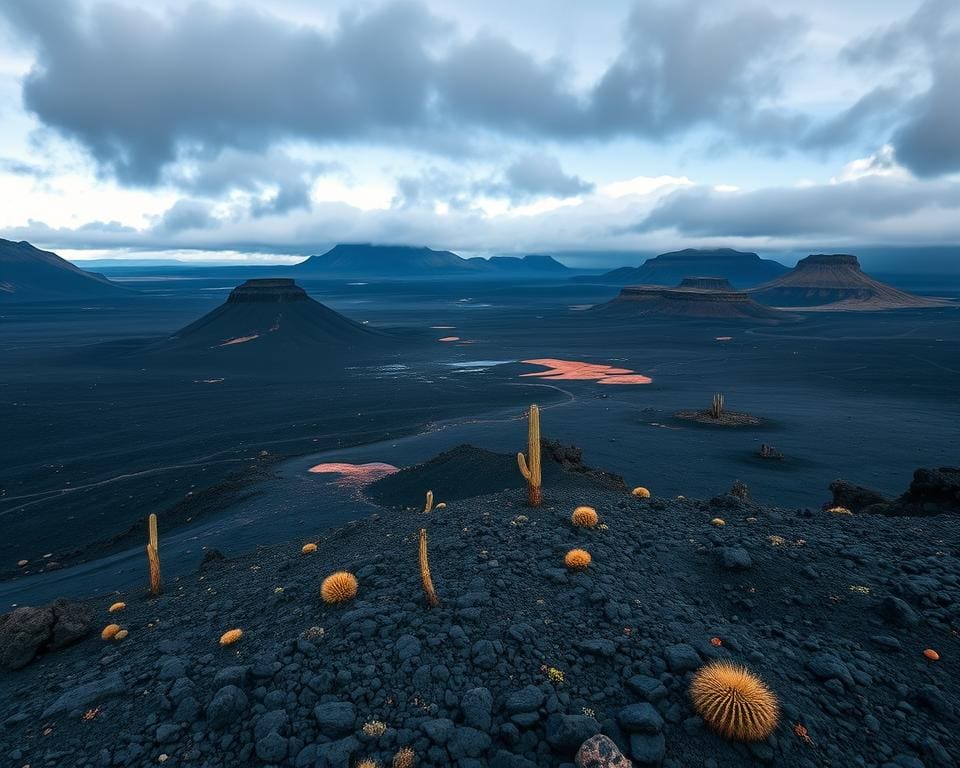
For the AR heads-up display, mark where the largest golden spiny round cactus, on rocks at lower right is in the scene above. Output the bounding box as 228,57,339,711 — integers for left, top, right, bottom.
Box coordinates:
690,661,780,741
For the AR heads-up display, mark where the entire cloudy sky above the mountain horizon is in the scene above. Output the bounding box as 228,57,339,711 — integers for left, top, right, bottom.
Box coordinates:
0,0,960,262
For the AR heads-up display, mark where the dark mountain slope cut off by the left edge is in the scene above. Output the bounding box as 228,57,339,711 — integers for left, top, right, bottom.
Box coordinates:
0,238,132,302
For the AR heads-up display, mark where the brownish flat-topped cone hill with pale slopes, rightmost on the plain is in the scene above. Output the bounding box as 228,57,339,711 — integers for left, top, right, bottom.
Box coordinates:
751,253,944,310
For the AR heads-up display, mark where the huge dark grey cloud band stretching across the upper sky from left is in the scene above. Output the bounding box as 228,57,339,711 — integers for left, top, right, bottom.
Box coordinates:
0,0,824,184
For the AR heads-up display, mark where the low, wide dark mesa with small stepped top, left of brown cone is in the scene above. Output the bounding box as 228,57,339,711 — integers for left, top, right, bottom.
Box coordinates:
591,278,796,323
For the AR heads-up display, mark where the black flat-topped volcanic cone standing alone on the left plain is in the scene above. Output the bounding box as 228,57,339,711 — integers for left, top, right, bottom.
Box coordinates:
148,278,392,367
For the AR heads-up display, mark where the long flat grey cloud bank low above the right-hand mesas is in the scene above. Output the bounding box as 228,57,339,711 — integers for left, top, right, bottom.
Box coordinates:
630,176,960,237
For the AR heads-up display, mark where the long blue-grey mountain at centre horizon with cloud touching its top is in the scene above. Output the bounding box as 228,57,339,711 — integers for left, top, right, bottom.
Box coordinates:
291,243,567,278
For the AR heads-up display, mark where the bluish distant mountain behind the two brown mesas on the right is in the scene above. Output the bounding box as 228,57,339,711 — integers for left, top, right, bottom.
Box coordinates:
574,248,789,288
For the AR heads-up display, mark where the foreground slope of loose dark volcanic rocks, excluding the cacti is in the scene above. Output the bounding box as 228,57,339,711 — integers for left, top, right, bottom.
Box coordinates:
0,450,960,768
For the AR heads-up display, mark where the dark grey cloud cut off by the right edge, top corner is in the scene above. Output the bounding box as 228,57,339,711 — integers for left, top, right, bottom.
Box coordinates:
844,0,960,177
